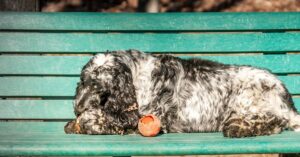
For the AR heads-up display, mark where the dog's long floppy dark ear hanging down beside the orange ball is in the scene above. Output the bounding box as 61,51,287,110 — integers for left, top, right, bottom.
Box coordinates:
95,59,139,128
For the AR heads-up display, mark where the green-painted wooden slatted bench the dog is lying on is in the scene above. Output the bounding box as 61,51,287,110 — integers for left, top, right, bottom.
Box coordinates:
0,12,300,156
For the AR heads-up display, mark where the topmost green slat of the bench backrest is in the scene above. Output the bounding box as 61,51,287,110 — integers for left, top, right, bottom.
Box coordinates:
0,12,300,31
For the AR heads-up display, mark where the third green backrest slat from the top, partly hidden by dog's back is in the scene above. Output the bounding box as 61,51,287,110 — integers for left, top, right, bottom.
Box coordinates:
0,54,300,75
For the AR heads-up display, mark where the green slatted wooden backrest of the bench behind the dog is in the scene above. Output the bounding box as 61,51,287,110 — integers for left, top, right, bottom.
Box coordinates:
0,13,300,121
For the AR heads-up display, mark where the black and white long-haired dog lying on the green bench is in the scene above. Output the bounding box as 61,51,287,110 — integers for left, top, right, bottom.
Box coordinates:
65,50,300,137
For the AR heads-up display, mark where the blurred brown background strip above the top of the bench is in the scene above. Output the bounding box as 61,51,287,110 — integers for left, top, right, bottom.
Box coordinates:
0,0,300,12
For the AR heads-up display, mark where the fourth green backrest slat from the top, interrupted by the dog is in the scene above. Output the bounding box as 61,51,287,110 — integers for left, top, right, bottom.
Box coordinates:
0,76,300,97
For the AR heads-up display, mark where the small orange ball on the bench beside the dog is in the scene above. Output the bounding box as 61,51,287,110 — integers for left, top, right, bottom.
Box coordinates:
138,114,160,137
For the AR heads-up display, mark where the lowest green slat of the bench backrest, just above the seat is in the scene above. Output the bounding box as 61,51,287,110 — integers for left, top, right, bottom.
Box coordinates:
0,97,300,120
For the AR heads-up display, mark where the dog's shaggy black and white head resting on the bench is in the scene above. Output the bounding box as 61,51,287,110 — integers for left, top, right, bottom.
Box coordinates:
74,55,139,134
